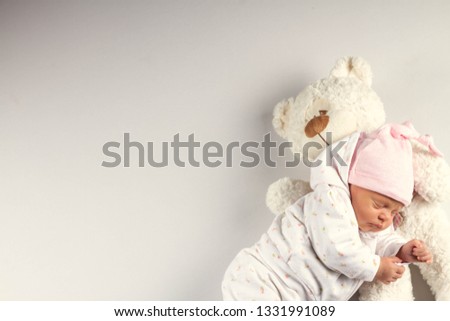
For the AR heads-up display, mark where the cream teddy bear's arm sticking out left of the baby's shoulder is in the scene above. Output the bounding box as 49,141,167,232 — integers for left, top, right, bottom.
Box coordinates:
266,177,311,215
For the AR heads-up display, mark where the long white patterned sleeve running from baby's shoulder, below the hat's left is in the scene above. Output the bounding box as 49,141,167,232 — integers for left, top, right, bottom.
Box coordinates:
304,184,380,281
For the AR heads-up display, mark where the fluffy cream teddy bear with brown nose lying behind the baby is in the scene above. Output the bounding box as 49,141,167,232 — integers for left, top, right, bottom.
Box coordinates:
266,57,450,300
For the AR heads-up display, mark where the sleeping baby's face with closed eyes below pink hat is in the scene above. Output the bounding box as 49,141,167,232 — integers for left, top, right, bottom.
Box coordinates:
350,185,403,232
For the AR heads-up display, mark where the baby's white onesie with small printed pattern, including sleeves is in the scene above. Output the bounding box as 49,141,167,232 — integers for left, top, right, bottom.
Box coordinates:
222,132,406,301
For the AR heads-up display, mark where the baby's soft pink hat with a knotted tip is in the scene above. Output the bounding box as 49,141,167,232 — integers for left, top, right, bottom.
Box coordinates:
348,122,442,206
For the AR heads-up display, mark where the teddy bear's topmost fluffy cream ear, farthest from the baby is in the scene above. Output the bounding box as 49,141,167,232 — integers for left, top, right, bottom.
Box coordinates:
330,57,372,87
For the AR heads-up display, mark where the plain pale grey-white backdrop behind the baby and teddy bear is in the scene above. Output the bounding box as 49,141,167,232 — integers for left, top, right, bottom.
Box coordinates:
0,0,450,300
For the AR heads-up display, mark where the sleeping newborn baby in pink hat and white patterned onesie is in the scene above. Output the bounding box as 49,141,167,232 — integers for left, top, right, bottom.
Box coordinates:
222,123,441,301
